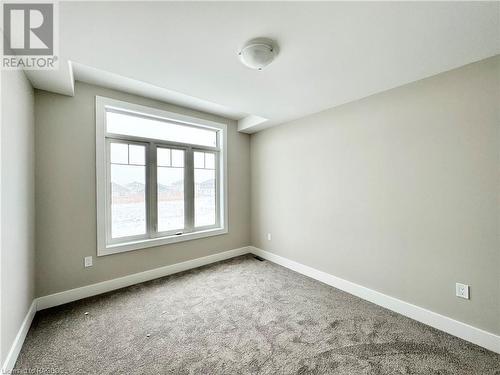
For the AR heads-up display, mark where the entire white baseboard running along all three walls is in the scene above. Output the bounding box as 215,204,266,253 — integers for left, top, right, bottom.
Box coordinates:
6,246,500,373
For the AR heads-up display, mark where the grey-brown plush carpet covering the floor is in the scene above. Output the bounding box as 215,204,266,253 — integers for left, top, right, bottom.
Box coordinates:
15,255,500,375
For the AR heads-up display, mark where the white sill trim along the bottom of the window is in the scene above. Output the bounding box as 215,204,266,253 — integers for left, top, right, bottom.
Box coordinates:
97,228,227,256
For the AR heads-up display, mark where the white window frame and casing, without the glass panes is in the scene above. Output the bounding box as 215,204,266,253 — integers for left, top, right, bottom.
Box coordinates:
95,96,228,256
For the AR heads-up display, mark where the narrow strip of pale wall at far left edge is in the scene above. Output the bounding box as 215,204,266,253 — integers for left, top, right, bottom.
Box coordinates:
0,71,35,364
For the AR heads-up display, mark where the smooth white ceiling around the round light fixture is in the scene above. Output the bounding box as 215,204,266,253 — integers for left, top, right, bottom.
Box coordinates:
30,2,500,132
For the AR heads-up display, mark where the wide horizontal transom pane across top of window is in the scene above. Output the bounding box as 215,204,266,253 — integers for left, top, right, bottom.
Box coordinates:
106,112,217,147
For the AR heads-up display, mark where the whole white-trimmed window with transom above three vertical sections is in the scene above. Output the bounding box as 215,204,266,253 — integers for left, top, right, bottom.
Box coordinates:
96,97,227,255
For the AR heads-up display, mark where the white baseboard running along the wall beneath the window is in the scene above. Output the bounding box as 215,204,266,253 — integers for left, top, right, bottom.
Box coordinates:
37,246,249,310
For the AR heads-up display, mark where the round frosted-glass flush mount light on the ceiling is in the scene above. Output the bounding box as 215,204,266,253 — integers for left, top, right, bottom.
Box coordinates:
238,38,279,70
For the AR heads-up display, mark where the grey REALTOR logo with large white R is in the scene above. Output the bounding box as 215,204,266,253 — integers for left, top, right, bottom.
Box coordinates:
2,3,57,69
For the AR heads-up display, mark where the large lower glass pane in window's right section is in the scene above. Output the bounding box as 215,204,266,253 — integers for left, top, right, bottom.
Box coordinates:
194,168,216,227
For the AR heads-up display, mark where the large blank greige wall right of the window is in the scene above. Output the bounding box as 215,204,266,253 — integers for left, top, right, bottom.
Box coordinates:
251,57,500,334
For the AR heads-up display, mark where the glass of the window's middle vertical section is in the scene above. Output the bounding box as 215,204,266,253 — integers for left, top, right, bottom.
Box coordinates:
157,149,184,232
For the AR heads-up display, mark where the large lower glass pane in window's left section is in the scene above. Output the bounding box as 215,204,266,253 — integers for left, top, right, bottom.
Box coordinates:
111,164,146,238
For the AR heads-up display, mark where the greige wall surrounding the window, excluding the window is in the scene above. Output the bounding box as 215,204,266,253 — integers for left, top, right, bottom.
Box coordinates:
35,82,250,296
